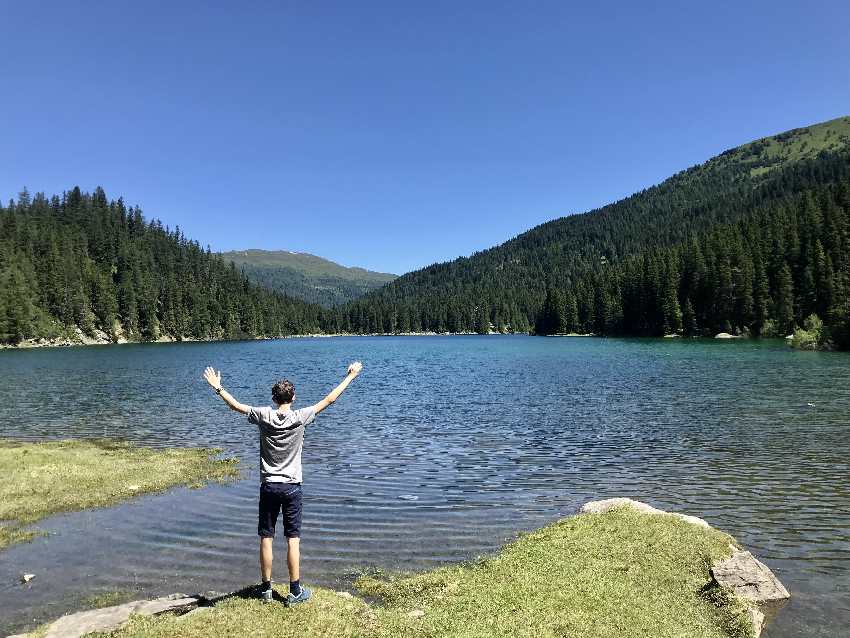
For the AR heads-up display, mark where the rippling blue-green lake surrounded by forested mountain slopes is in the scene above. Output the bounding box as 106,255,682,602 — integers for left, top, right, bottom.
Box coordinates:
0,336,850,638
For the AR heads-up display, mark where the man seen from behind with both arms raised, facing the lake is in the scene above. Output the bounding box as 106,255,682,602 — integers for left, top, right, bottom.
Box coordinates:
204,361,363,605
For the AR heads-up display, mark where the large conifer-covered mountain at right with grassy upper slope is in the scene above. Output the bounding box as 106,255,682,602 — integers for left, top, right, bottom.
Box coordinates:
330,117,850,344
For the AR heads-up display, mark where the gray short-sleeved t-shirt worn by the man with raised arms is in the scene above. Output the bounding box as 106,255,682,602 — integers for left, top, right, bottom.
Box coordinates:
248,406,316,483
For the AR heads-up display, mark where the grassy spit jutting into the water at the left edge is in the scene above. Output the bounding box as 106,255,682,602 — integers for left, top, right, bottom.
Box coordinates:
0,439,238,549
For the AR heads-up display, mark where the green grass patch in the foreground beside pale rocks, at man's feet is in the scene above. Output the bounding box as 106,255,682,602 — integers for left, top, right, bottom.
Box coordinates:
96,509,752,638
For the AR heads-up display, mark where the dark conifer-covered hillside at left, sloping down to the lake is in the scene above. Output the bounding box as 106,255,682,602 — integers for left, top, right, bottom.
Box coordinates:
0,188,322,343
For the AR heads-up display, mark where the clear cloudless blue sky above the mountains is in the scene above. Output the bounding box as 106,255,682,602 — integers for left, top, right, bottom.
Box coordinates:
0,0,850,273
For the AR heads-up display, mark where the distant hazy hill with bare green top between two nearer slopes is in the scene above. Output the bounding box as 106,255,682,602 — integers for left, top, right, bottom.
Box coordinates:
221,249,396,307
